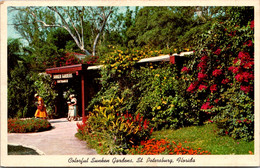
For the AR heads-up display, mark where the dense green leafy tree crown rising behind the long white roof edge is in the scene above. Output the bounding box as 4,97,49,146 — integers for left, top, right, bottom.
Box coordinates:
127,7,196,48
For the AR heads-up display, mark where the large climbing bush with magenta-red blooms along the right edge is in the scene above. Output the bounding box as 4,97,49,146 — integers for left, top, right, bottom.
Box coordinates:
182,18,254,140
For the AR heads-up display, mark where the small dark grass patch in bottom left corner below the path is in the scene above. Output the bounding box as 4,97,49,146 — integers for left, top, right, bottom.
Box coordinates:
8,145,39,155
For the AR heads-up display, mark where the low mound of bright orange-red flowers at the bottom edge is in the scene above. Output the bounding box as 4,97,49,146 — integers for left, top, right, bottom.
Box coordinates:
129,138,211,155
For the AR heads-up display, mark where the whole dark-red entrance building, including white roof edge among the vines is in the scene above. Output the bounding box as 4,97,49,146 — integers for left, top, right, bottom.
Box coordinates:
46,51,193,118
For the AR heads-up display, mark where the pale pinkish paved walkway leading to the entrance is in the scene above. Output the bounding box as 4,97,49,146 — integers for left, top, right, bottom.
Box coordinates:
8,118,97,155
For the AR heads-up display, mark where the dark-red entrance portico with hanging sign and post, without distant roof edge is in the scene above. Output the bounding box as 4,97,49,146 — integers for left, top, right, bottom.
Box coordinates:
45,64,100,118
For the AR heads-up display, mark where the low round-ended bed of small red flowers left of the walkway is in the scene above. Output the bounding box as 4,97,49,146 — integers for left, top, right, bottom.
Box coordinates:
8,119,52,133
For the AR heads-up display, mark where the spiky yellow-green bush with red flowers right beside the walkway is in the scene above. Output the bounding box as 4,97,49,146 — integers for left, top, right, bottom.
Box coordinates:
77,97,153,154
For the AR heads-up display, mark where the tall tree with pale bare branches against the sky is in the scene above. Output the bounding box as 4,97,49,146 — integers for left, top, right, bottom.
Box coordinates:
11,6,113,56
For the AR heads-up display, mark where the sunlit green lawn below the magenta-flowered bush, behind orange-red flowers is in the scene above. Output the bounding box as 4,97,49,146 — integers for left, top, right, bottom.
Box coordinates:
151,124,254,155
